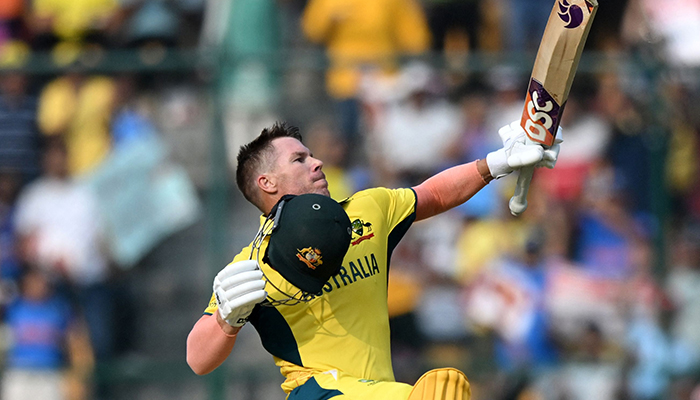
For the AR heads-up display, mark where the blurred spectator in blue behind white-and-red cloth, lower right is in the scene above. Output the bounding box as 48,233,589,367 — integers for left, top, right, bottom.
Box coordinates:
465,226,561,395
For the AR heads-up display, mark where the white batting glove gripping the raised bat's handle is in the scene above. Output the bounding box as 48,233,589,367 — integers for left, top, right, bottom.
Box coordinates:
486,121,562,179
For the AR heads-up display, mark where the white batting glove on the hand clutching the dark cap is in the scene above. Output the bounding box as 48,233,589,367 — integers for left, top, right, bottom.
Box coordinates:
214,260,267,328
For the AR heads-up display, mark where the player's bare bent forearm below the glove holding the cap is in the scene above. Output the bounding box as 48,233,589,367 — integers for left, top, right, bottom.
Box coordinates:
187,313,239,375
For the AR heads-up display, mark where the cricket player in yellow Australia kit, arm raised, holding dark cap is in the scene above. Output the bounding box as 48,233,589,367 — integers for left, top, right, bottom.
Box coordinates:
187,122,559,400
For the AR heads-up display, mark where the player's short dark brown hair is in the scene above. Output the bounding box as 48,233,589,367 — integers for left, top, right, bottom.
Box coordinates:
236,122,302,212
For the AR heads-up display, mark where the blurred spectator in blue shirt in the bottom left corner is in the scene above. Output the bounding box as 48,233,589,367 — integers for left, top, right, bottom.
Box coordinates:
2,268,94,400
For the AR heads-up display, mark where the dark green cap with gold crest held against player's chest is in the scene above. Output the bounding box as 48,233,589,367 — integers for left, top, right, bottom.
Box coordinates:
263,194,352,294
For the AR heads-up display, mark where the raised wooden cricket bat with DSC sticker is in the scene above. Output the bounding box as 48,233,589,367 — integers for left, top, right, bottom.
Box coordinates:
508,0,598,216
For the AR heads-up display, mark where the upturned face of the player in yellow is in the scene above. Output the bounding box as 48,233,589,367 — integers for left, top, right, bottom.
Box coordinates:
268,137,330,196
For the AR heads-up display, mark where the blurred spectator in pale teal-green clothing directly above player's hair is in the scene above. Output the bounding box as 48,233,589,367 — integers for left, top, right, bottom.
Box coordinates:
201,0,280,170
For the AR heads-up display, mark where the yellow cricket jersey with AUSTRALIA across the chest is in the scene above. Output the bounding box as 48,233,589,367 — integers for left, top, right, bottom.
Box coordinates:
205,188,416,393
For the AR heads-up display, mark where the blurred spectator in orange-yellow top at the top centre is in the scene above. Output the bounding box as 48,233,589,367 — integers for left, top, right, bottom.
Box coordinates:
302,0,430,152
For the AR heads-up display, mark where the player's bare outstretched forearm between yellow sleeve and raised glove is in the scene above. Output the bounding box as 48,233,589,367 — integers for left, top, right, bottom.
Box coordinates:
413,160,493,220
